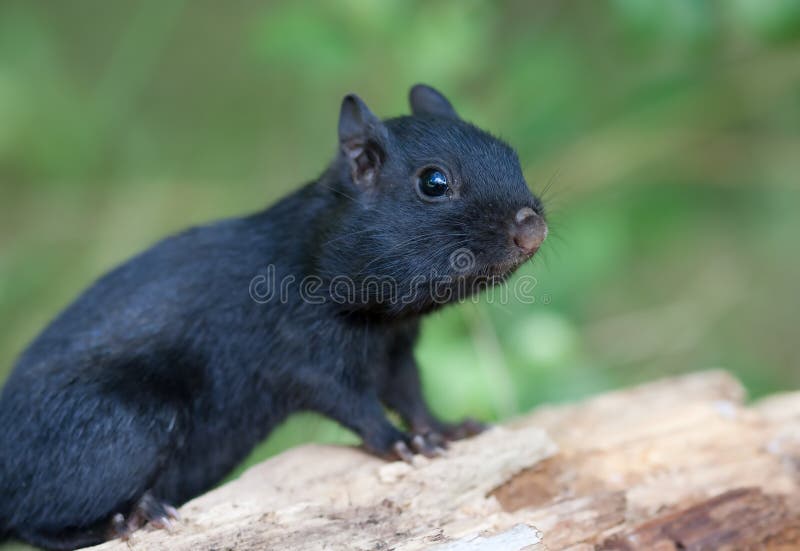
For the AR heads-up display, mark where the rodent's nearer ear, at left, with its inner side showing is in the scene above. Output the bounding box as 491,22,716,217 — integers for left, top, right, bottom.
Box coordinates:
339,94,388,187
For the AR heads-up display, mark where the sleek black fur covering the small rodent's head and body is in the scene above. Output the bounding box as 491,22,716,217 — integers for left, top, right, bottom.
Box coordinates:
0,87,542,549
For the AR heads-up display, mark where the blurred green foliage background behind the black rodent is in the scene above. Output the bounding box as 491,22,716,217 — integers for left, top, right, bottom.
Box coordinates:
0,0,800,548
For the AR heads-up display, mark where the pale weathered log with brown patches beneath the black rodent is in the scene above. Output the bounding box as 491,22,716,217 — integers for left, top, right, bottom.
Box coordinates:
86,372,800,551
